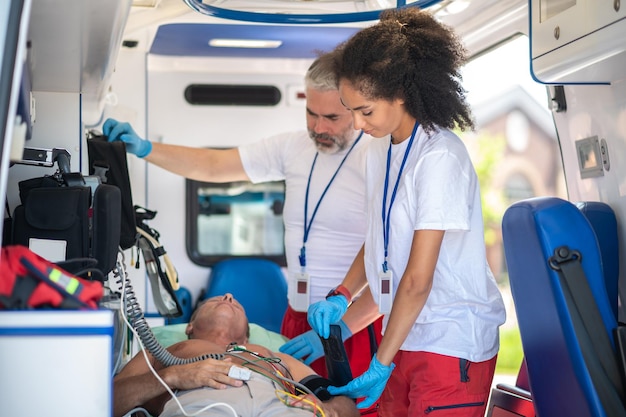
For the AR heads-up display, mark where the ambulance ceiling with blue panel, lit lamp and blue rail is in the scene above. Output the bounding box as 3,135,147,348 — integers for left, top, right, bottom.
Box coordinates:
143,0,527,58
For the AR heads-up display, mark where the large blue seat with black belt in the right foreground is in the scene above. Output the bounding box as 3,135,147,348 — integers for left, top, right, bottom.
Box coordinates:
502,197,626,417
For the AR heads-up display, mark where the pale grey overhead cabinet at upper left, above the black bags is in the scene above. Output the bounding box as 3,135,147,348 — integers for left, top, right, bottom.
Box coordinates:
28,0,133,124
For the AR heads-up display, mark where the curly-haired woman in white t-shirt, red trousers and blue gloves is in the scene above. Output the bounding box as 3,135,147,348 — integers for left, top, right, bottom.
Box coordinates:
308,8,505,417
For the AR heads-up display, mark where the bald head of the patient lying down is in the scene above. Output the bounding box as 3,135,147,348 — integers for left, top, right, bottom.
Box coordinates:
185,293,250,345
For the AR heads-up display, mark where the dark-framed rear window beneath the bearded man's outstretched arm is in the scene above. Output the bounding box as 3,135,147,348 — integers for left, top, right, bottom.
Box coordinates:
186,180,286,266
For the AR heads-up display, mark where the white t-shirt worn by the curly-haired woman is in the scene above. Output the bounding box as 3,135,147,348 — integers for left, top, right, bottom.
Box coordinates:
365,126,505,362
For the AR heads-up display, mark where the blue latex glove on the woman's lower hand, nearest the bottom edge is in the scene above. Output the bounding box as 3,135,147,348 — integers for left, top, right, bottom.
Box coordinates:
328,355,396,409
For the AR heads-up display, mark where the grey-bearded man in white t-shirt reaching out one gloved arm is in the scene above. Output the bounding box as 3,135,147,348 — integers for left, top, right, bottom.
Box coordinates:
102,53,382,376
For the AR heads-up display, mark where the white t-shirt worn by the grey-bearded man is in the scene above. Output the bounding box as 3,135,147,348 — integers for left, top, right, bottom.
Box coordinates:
239,131,371,311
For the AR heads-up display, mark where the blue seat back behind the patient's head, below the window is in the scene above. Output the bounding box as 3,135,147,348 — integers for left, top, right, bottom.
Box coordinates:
203,258,287,333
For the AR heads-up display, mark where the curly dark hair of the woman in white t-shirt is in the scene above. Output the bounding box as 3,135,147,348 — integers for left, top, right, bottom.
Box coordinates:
335,7,474,132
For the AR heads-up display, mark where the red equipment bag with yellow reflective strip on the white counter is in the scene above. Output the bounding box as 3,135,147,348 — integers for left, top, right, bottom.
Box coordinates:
0,245,103,310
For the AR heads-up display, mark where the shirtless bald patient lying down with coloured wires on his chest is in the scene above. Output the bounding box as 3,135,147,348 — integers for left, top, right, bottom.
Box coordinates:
113,294,359,417
